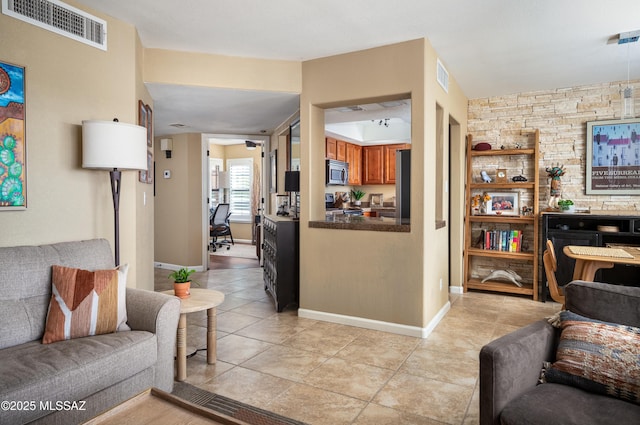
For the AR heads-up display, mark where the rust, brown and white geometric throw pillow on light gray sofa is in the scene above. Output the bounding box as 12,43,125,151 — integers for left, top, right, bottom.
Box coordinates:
42,264,130,344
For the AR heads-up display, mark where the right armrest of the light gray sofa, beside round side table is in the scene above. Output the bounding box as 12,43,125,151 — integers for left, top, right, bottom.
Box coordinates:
127,288,180,392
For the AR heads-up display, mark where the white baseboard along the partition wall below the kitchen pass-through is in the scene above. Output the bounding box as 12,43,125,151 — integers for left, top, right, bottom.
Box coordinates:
298,301,451,338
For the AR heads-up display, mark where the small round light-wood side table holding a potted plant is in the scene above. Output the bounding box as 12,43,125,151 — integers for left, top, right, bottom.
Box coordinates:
162,288,224,381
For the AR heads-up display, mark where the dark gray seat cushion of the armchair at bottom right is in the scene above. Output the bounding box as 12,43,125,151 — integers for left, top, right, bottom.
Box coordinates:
500,384,640,425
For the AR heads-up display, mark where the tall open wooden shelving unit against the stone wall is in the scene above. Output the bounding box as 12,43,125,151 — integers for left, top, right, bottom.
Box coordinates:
464,130,540,300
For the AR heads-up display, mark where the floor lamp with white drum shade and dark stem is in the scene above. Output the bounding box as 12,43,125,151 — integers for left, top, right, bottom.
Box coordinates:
82,120,147,267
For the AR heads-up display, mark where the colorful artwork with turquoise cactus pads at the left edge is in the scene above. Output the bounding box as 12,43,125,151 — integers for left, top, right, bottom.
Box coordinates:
0,61,27,211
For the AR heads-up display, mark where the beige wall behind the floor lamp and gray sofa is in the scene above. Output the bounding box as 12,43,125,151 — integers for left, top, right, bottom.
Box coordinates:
0,3,153,287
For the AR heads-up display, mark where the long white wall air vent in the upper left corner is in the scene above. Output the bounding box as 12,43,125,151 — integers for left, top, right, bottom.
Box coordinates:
2,0,107,50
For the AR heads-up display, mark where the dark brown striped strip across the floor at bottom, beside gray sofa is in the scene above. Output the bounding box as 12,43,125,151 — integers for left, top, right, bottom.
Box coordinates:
171,382,306,425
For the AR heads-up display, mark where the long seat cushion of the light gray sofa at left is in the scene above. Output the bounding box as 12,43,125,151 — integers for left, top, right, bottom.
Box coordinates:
0,331,158,423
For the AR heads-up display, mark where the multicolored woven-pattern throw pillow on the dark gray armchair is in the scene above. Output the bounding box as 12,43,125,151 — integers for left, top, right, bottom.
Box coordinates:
544,311,640,404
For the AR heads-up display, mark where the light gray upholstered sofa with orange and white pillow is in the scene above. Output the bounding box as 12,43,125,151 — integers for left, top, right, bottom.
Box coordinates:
0,239,180,425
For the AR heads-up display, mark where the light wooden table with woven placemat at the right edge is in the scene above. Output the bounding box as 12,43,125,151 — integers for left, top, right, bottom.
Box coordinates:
562,245,640,282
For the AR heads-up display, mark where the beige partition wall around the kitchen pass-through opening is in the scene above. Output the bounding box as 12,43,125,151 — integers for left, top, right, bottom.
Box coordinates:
300,40,467,328
